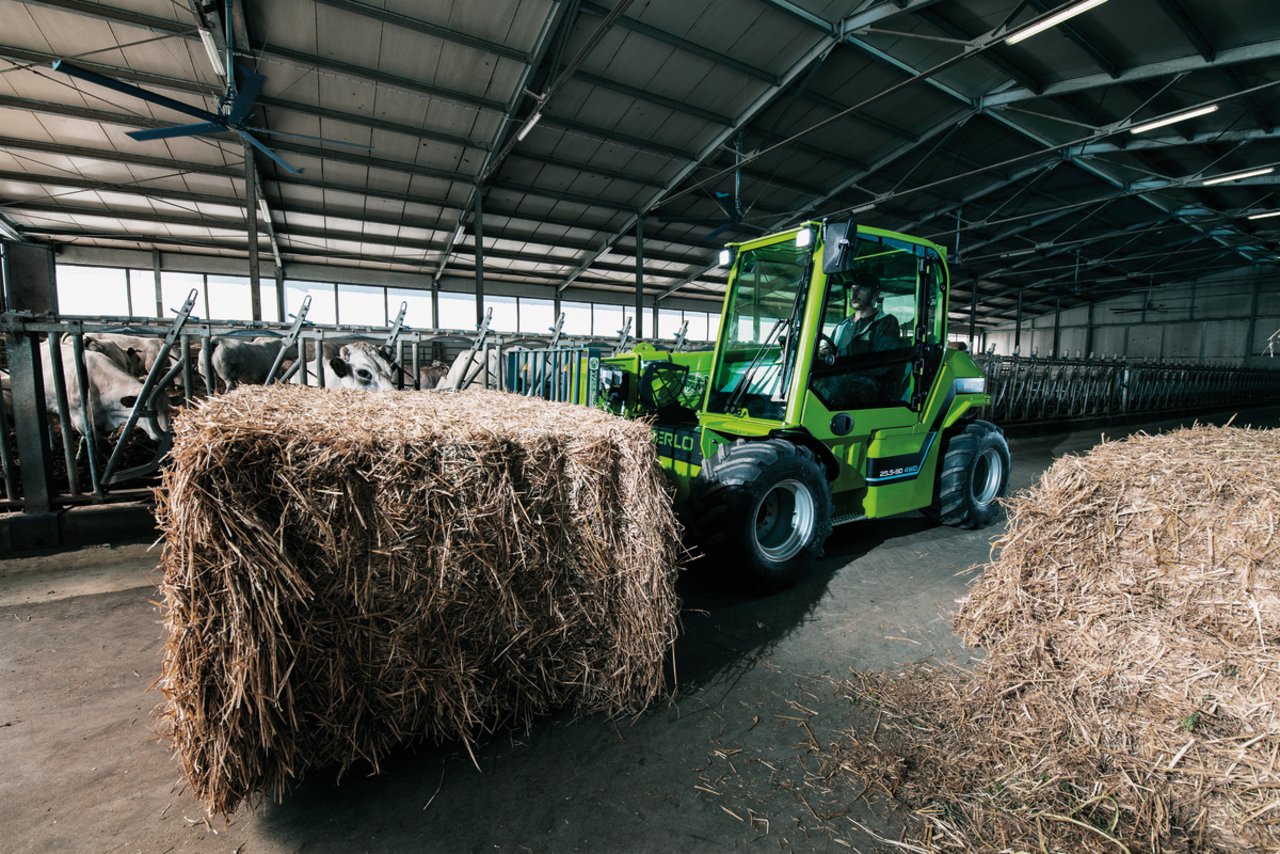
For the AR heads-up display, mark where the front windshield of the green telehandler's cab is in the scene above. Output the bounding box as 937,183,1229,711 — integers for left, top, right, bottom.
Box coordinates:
707,239,813,421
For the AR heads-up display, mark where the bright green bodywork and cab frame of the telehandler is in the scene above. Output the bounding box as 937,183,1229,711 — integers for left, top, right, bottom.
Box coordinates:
565,223,991,517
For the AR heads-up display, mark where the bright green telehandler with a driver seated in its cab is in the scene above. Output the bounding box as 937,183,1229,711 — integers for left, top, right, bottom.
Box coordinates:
507,220,1010,589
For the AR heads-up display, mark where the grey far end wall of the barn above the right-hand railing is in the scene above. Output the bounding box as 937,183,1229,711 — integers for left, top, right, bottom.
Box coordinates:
986,266,1280,366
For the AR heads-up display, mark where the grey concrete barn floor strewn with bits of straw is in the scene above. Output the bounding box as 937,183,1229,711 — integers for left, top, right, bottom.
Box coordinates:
0,408,1280,853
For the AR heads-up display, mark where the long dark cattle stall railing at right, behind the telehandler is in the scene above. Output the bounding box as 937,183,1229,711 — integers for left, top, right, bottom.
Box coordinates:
977,353,1280,424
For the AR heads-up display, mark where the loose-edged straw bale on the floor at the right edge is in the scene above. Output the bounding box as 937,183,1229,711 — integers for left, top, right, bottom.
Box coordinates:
840,426,1280,851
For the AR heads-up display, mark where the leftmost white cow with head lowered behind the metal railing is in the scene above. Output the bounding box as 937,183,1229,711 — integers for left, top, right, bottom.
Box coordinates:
44,344,169,442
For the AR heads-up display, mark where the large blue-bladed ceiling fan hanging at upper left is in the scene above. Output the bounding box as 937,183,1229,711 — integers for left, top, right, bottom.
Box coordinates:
54,0,371,174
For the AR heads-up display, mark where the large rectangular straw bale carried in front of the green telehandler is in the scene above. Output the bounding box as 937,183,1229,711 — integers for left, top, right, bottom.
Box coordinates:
159,387,678,813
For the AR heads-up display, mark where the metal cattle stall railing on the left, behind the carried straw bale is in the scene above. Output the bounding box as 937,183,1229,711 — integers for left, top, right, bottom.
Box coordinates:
0,307,701,513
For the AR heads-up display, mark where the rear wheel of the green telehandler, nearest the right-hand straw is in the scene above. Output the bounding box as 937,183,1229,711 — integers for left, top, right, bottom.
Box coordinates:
928,421,1011,528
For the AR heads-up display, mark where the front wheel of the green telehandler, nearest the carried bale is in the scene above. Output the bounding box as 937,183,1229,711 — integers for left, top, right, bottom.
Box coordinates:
691,439,831,592
